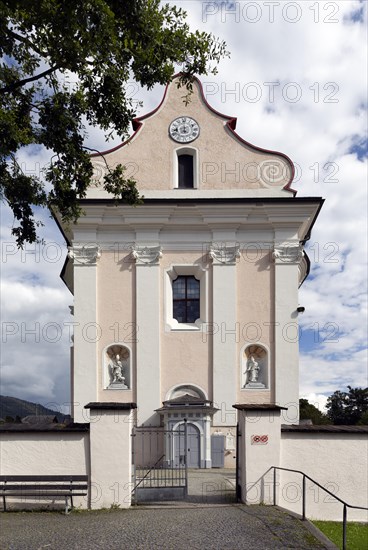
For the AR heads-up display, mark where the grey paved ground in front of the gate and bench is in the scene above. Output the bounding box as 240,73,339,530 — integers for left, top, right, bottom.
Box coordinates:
0,503,327,550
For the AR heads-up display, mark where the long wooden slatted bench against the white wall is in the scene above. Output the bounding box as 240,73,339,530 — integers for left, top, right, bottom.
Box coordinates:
0,475,88,514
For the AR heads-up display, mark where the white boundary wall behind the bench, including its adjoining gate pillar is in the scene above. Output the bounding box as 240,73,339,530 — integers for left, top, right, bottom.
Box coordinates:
0,403,136,509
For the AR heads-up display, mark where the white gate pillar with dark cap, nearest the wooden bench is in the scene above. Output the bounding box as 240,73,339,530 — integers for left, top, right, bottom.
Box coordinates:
85,403,136,509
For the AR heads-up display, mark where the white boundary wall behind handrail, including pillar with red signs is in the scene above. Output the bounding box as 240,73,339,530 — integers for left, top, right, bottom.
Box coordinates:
235,404,368,522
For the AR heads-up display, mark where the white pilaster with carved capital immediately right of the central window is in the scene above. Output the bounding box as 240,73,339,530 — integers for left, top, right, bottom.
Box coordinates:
210,244,239,426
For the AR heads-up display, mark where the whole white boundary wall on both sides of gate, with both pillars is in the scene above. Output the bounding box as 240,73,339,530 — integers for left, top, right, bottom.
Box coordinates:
0,403,368,522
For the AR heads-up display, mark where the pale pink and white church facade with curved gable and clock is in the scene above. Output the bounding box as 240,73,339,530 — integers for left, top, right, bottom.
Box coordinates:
60,73,323,468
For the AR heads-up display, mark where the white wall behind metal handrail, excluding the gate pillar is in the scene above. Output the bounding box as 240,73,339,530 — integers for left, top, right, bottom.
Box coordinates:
278,432,368,521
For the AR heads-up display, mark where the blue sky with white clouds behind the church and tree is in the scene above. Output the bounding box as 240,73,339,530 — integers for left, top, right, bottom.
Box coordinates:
0,0,367,414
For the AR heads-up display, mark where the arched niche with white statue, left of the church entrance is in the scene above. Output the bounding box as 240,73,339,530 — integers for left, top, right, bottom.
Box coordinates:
104,344,131,390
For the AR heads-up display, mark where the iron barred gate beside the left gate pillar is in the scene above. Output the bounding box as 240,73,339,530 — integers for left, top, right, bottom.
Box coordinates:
132,422,188,502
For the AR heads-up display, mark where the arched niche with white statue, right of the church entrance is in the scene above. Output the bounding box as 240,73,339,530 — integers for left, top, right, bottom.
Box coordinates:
241,344,269,390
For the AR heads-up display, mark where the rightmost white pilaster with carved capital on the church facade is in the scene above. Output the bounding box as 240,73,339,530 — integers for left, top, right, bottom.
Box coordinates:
273,240,302,424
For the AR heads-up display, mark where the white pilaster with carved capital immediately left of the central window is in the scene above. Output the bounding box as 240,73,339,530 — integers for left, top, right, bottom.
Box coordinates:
132,245,162,425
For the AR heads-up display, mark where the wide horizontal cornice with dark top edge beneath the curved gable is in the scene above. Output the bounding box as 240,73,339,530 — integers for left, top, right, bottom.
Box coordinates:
69,201,323,241
